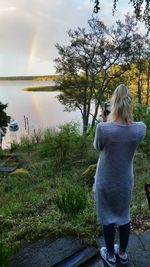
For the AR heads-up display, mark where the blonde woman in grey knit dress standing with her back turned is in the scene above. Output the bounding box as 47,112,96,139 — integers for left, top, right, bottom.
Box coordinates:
94,84,146,267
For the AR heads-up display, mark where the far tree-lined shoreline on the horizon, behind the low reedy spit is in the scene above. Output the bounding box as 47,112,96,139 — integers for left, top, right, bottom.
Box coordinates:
0,75,58,81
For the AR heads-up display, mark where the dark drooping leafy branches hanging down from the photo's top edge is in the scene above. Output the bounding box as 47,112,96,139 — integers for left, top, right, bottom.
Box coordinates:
93,0,150,32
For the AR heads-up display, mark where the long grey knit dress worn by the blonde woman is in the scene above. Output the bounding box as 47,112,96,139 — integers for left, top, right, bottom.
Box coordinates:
93,121,146,225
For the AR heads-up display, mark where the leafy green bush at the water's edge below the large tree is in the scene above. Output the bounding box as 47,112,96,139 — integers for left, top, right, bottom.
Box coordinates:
39,123,87,164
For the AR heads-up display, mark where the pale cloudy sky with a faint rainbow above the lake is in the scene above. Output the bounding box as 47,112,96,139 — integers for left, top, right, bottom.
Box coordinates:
0,0,141,76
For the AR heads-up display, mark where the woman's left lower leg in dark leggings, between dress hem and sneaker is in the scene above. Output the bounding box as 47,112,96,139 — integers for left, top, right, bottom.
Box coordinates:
103,223,115,256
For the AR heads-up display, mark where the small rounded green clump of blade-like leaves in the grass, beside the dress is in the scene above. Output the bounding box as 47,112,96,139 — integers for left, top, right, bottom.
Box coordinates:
54,180,87,217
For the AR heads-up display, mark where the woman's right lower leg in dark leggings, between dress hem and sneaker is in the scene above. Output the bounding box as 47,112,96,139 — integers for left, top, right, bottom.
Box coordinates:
119,222,130,252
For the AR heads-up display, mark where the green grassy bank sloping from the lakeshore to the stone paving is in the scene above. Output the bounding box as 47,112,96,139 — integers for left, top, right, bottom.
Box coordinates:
0,124,150,266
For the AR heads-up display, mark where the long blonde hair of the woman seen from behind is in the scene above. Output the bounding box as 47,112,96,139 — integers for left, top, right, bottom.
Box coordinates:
108,84,133,123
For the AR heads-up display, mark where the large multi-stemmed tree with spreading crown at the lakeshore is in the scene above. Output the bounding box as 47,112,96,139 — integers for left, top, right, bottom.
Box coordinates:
55,15,136,134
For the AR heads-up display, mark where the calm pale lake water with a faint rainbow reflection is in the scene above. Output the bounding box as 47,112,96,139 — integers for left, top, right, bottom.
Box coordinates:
0,81,81,148
